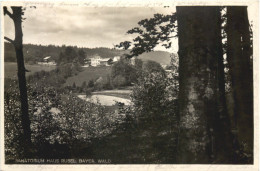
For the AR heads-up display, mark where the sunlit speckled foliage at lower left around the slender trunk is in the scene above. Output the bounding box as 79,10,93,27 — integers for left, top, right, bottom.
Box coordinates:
5,82,124,162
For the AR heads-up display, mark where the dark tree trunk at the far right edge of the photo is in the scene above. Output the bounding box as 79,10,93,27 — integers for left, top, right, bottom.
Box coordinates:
227,7,254,160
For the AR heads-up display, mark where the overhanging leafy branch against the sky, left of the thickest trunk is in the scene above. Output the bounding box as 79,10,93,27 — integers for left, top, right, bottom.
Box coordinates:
116,13,177,58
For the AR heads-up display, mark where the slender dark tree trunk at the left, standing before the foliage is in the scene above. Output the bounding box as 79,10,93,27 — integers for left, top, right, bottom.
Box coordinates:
12,7,31,155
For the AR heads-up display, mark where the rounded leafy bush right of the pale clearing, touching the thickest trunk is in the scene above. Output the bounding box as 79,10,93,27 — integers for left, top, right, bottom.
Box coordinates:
131,58,178,121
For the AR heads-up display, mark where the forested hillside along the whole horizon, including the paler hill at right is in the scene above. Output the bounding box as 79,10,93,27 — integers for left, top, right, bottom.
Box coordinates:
4,42,170,65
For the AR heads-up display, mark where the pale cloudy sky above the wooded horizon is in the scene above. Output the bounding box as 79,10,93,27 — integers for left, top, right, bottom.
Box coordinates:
4,6,177,51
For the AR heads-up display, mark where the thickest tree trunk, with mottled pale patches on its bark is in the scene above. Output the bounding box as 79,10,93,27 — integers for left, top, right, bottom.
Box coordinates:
177,7,232,163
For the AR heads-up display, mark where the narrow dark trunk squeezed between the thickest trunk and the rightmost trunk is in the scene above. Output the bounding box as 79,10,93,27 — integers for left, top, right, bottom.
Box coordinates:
214,9,234,164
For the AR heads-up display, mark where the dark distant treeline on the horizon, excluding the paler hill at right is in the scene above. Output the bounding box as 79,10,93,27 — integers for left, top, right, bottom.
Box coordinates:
4,42,126,63
